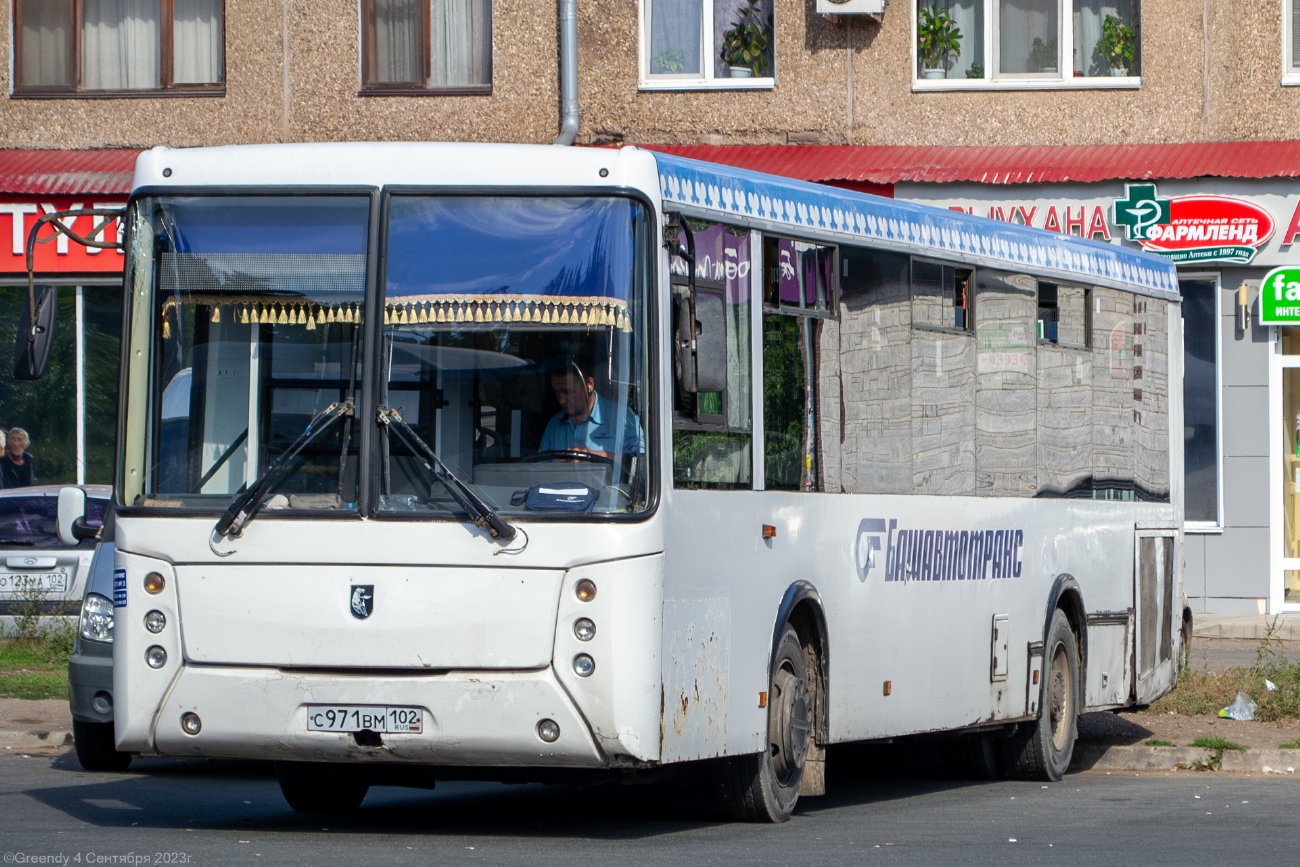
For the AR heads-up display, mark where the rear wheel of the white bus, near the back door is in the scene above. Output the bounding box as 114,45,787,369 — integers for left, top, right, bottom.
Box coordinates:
1006,608,1079,783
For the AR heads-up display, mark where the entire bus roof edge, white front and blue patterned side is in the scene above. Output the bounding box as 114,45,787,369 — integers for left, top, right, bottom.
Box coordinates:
133,142,1179,300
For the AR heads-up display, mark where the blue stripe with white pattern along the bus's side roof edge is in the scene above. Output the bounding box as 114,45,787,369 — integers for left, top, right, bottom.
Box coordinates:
654,152,1178,299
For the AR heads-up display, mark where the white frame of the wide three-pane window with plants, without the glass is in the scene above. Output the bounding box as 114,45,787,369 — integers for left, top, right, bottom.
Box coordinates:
910,0,1144,92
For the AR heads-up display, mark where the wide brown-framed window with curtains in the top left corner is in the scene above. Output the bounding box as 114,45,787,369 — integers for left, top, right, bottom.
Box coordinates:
13,0,225,96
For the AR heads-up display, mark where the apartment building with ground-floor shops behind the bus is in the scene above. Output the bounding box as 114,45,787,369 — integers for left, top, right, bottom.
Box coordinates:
0,0,1300,612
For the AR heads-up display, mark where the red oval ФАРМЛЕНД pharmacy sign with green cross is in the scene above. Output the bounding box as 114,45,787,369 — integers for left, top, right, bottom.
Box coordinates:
1112,183,1273,265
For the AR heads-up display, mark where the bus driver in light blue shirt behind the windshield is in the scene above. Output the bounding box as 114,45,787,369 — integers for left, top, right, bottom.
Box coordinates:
538,363,646,460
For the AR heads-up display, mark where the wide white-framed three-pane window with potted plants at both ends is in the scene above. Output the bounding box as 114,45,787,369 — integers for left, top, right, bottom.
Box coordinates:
915,0,1138,88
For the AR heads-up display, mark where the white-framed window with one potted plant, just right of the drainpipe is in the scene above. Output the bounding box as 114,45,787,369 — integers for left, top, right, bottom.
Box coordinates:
641,0,775,90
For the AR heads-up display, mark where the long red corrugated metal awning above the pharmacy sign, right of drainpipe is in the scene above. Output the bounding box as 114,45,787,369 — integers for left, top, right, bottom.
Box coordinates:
644,142,1300,186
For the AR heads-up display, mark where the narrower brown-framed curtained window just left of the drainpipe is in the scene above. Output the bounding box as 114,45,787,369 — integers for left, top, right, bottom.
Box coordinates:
361,0,491,94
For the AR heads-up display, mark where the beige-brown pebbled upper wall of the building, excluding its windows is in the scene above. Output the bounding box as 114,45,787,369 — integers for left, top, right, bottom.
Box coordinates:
0,0,1300,148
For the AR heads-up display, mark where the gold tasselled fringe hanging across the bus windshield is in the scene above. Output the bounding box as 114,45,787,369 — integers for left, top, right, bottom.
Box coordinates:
163,295,632,339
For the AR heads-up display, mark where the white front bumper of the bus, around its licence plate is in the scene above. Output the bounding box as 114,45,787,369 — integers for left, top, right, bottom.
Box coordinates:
142,666,608,768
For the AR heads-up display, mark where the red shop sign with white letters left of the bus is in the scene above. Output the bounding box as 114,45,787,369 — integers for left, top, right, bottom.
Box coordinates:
0,195,126,276
